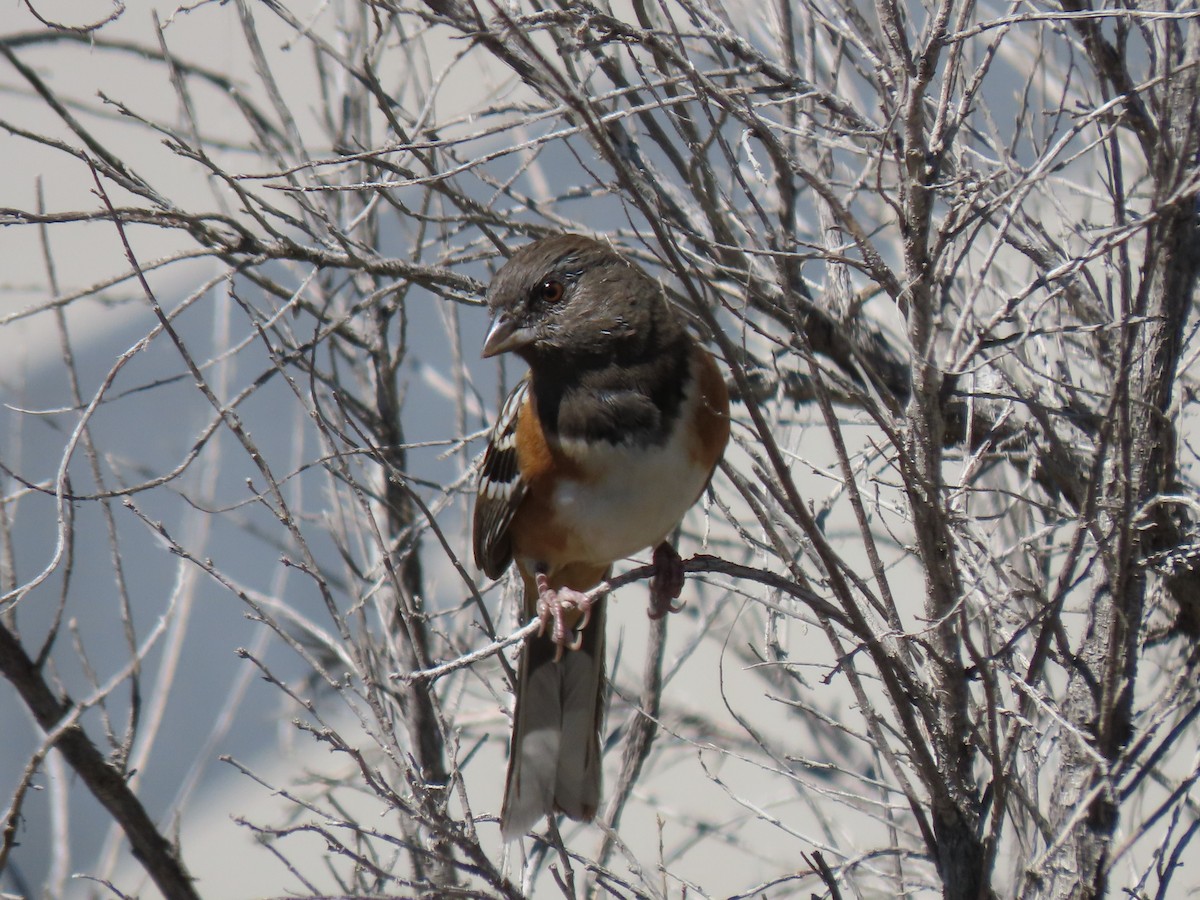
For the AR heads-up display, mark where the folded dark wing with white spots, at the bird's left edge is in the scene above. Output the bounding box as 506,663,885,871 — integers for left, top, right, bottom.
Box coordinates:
472,377,529,578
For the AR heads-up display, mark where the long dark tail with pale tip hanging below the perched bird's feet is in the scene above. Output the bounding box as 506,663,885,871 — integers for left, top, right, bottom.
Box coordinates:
500,598,606,841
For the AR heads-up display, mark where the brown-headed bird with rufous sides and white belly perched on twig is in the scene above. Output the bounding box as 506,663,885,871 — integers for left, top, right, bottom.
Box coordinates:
472,234,730,842
